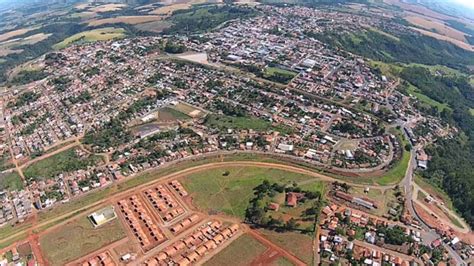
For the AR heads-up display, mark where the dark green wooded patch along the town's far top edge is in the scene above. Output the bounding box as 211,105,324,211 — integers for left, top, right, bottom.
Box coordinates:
163,5,256,34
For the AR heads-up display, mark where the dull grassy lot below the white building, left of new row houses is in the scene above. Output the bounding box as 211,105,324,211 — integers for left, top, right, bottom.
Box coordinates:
39,216,126,265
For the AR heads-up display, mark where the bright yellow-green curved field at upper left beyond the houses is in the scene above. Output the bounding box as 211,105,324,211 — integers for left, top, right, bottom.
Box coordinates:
53,27,125,49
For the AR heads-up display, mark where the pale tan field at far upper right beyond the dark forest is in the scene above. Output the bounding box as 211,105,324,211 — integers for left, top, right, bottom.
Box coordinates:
405,16,467,43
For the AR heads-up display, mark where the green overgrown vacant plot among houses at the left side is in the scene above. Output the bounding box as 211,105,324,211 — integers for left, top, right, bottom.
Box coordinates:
24,148,102,181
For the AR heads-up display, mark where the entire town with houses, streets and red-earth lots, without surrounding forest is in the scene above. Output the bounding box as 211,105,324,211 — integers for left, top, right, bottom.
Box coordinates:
0,0,474,265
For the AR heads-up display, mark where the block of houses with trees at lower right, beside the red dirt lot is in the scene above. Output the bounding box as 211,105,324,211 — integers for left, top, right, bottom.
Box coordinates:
319,204,456,265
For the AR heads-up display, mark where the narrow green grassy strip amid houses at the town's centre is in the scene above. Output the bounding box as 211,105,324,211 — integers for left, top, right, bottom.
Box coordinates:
206,115,292,134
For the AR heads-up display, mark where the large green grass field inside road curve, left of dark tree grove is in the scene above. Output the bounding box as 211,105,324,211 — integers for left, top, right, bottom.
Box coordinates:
183,167,313,219
